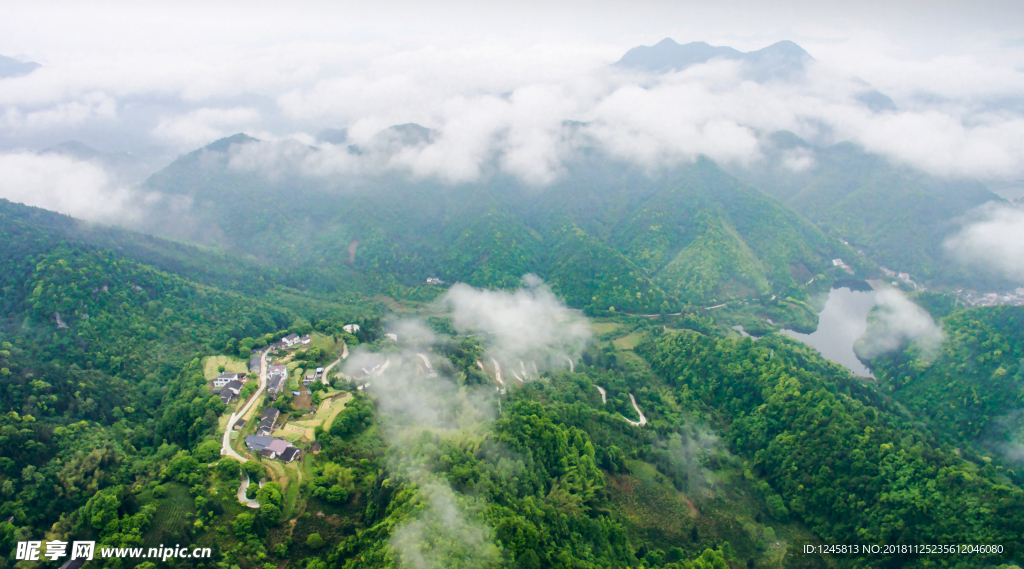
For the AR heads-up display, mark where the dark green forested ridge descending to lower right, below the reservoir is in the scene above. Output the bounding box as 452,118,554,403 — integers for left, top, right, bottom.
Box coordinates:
643,332,1024,560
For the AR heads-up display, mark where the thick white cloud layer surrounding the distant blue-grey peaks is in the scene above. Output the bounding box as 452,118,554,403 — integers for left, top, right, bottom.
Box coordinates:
0,12,1024,185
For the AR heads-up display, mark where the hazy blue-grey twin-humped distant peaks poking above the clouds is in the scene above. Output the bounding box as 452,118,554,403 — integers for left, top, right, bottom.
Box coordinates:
615,38,814,81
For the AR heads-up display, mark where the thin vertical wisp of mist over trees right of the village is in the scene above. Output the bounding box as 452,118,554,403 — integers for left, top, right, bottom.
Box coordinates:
345,333,501,569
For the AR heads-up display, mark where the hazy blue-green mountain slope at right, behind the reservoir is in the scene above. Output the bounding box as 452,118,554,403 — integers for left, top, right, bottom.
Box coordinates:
732,133,999,287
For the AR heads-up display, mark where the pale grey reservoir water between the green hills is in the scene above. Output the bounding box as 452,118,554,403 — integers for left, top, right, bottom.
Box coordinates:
782,289,876,377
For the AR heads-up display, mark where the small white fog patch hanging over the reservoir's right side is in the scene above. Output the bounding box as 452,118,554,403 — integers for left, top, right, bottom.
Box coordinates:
857,289,944,359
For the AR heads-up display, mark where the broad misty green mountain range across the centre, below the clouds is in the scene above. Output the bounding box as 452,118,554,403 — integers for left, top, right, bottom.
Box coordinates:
136,136,866,313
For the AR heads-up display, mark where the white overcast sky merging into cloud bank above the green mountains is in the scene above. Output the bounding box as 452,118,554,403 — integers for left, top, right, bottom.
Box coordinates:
0,0,1024,193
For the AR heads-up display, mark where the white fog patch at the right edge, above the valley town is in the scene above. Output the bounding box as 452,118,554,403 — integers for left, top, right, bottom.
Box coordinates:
944,203,1024,282
